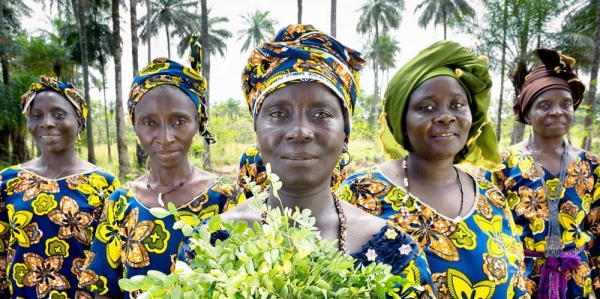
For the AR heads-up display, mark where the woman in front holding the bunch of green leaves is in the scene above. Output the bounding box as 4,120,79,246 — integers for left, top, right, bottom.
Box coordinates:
182,25,433,298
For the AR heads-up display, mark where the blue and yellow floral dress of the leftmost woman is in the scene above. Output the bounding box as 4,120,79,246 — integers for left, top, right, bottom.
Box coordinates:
0,165,119,299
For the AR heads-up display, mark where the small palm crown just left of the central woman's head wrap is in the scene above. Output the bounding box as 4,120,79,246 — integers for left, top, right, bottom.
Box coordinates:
238,10,277,52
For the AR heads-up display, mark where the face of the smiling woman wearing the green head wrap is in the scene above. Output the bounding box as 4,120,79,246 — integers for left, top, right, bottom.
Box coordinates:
406,76,472,160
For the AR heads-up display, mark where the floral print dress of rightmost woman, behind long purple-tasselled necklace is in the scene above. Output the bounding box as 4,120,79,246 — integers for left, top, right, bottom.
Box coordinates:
486,146,600,298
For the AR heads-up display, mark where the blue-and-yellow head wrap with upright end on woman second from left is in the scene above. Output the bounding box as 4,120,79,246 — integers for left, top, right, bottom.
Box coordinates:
127,34,216,144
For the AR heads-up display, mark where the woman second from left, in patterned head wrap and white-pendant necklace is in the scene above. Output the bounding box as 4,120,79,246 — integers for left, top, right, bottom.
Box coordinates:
80,37,244,298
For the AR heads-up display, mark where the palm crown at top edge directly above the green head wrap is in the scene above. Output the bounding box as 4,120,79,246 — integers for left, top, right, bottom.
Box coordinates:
415,0,475,39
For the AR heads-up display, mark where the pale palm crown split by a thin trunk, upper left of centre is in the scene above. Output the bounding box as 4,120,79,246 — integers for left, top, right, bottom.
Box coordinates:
177,9,233,57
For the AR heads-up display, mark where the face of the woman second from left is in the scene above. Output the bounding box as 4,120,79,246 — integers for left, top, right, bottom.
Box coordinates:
134,85,199,168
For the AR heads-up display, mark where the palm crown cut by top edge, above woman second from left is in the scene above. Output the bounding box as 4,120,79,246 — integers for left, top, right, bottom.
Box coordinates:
139,0,199,58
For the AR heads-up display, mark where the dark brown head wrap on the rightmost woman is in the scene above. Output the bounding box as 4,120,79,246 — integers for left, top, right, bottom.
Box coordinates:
513,49,585,124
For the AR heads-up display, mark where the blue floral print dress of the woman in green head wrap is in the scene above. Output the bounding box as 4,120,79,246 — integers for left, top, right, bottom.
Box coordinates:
337,166,529,299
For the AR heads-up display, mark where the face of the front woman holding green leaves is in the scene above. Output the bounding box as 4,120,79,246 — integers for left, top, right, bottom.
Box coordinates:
256,82,347,191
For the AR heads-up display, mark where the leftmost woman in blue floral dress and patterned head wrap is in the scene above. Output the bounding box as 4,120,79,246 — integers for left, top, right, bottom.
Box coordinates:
0,76,119,298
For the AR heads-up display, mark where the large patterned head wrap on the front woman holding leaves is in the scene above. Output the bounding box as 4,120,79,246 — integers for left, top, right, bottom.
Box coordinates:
242,25,365,138
